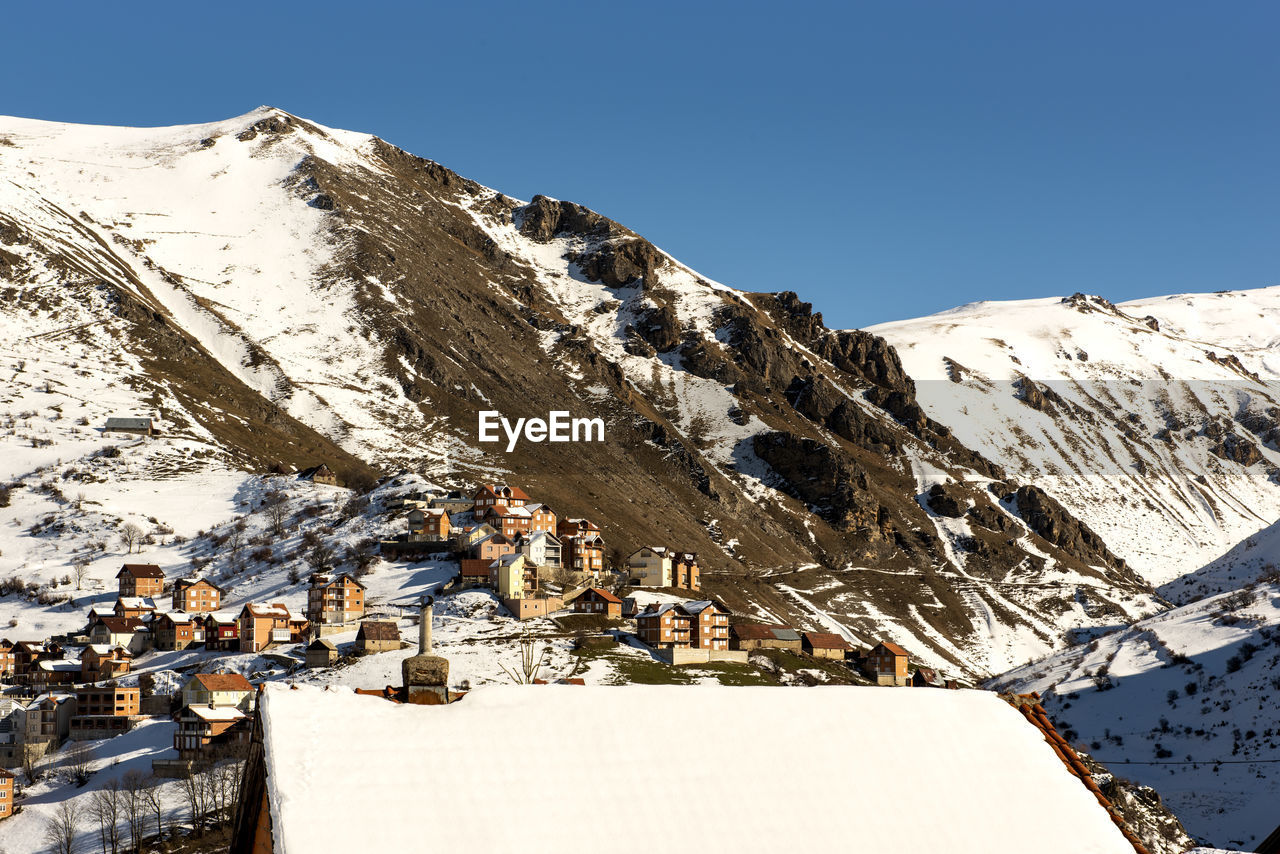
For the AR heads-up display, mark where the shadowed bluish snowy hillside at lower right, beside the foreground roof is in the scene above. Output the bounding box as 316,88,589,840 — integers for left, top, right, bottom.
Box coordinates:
989,574,1280,850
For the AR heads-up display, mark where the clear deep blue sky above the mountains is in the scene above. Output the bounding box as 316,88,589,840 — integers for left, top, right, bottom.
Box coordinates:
0,0,1280,326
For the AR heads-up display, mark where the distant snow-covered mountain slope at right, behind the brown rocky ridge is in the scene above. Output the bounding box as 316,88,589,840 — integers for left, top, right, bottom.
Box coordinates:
872,287,1280,595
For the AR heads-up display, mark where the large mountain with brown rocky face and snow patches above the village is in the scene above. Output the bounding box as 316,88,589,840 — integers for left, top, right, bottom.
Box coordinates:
0,108,1239,675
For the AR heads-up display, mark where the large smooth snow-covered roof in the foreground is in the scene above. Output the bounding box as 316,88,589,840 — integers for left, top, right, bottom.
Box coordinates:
262,685,1134,854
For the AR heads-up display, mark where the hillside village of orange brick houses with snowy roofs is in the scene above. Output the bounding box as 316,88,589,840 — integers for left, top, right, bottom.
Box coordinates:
0,465,961,818
